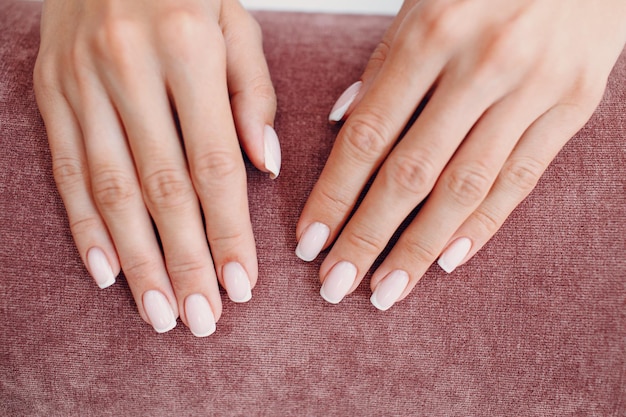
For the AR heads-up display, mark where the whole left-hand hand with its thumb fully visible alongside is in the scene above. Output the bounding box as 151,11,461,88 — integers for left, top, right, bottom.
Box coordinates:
34,0,280,336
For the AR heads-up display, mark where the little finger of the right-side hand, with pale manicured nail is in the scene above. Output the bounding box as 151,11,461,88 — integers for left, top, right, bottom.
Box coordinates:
438,105,590,272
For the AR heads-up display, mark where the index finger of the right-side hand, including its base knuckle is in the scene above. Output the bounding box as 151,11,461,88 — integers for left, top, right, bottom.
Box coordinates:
296,2,486,260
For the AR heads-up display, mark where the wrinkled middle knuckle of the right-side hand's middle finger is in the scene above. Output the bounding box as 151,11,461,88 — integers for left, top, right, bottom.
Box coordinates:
385,155,436,196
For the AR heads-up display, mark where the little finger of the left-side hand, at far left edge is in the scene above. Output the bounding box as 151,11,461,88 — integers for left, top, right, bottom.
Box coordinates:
35,75,120,288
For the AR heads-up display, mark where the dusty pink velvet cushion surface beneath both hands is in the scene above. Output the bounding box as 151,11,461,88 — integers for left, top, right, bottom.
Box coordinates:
0,2,626,416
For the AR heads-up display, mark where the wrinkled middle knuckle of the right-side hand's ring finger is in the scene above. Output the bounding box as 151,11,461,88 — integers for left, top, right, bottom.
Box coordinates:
444,163,492,207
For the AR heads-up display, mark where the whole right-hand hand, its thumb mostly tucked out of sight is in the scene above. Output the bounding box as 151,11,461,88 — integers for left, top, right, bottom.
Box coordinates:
296,0,626,310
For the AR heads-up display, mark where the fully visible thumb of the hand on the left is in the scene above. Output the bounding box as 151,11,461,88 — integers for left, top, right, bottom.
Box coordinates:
222,2,281,179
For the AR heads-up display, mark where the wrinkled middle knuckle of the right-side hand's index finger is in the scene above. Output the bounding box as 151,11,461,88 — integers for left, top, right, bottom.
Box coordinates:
342,111,391,164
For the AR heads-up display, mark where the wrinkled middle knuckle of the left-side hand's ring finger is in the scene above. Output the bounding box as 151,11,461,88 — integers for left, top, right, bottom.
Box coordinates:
91,170,137,211
